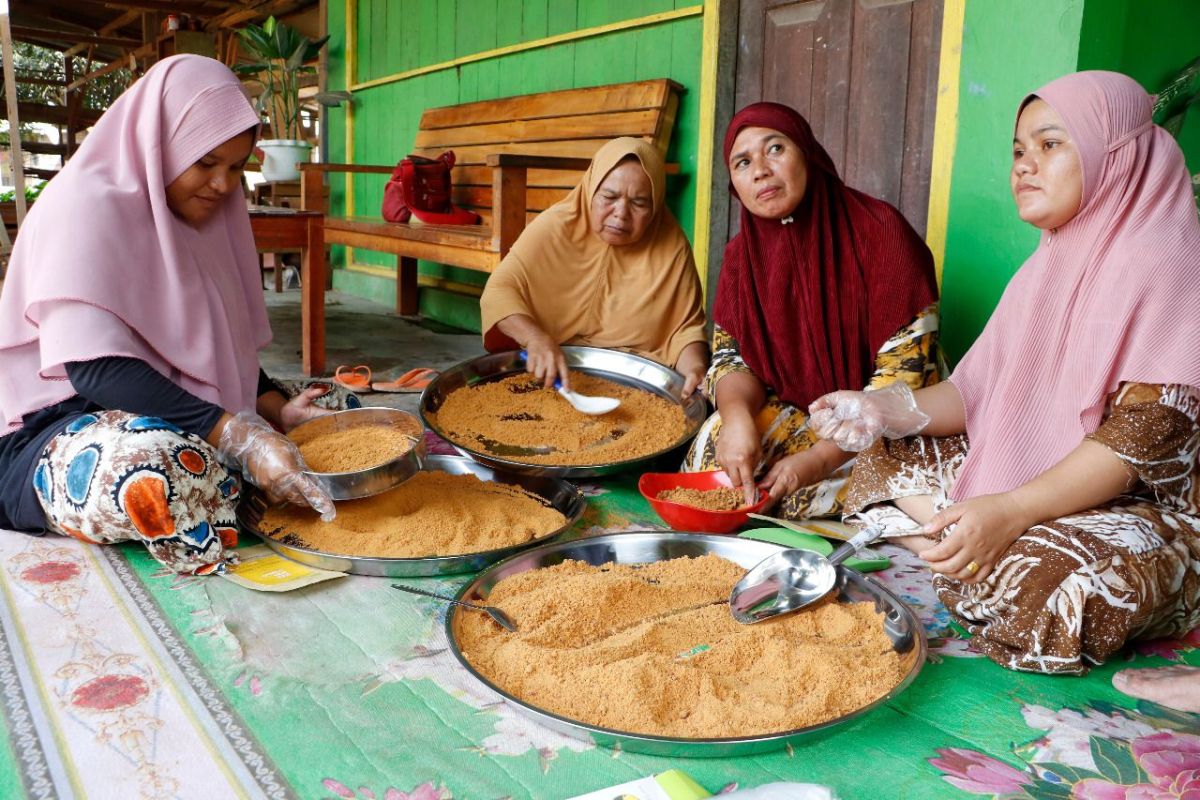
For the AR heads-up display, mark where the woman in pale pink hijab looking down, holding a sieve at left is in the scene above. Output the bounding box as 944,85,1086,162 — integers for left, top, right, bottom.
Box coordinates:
0,55,332,575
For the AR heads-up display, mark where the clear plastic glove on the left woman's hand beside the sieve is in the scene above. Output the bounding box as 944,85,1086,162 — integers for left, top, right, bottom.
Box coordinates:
217,411,337,522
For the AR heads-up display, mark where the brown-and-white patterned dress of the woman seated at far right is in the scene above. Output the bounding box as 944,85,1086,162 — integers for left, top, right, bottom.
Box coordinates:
846,384,1200,674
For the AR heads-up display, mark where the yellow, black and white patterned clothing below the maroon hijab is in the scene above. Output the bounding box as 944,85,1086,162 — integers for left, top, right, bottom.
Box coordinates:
682,303,938,519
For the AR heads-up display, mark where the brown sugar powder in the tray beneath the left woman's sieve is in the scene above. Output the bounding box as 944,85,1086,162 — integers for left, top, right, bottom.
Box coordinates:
259,470,566,558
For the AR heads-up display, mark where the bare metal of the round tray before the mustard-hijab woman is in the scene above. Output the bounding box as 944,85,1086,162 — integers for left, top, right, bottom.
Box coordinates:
420,347,708,477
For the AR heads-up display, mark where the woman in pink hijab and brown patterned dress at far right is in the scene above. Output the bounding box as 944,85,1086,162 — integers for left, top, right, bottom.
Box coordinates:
812,72,1200,681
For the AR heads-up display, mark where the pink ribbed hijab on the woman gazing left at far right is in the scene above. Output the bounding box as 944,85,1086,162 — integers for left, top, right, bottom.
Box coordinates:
950,72,1200,500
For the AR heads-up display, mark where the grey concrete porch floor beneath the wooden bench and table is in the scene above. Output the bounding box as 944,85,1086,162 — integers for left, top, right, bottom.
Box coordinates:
260,275,484,411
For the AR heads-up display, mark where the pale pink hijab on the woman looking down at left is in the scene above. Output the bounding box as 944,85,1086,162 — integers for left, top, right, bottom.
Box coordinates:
0,55,271,434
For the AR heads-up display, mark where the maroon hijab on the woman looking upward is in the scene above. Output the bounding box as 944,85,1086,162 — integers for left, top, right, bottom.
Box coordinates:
713,103,937,408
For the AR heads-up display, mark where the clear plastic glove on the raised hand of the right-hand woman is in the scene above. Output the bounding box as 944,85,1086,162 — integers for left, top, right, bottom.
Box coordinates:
809,380,929,452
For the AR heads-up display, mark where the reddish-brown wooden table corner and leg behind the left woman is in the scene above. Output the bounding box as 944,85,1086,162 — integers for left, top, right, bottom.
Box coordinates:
250,205,325,377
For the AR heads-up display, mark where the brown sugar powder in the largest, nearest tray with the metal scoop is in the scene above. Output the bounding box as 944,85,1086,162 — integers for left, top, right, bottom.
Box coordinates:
458,554,906,739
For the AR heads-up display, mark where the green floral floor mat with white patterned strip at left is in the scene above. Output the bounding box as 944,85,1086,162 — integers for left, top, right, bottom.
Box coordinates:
0,477,1200,800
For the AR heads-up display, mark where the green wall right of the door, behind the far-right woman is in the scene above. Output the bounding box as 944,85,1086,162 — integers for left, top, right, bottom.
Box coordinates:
942,0,1200,363
